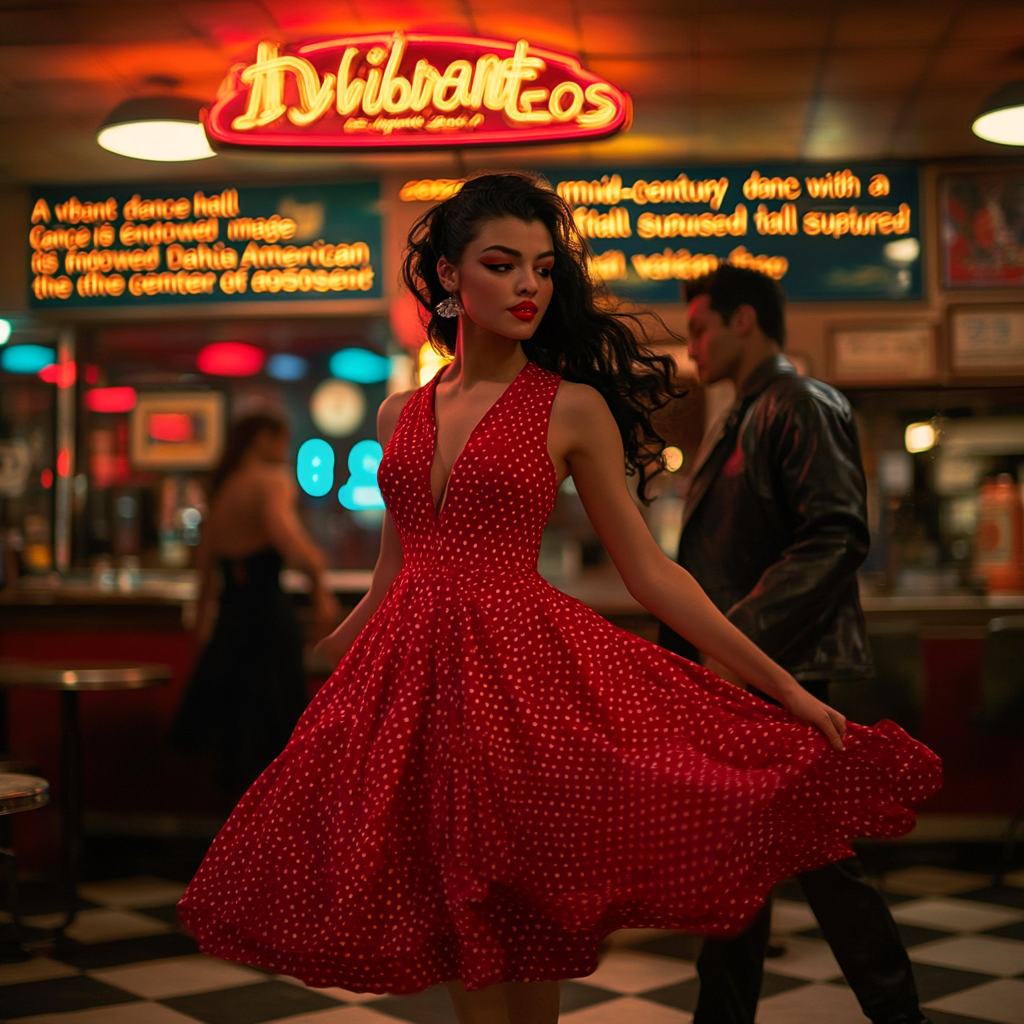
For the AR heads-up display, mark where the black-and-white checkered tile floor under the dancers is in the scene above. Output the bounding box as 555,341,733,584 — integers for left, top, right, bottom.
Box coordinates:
0,867,1024,1024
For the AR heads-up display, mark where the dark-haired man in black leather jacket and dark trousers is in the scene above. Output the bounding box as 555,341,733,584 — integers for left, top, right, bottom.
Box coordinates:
659,264,925,1024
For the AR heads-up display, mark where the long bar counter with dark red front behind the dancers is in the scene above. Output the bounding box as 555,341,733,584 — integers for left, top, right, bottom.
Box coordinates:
0,566,1024,847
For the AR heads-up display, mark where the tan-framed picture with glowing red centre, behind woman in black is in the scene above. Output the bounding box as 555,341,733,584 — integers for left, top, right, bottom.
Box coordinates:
130,391,226,470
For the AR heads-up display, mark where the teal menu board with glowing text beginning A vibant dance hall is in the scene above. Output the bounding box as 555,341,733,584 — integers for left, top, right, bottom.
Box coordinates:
28,182,383,309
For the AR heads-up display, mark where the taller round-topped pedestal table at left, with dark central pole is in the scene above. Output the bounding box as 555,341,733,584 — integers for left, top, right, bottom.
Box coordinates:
0,660,171,938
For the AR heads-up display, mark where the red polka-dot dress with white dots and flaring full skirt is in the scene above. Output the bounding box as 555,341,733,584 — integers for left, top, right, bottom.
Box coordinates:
179,362,940,992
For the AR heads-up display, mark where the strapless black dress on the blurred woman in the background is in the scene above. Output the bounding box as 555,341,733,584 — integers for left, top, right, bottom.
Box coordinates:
171,548,308,796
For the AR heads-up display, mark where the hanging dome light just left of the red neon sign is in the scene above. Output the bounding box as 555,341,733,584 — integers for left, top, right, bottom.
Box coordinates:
96,96,217,163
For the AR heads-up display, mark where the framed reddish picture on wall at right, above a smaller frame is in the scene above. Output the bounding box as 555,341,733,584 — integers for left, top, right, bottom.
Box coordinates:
939,170,1024,288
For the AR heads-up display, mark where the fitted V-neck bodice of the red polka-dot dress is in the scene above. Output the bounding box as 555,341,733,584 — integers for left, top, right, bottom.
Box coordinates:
378,362,561,575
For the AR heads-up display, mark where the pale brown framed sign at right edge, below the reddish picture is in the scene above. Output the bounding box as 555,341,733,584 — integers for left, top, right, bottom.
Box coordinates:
949,303,1024,377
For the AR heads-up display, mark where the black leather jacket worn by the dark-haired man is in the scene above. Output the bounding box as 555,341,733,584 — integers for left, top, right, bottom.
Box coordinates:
659,355,873,682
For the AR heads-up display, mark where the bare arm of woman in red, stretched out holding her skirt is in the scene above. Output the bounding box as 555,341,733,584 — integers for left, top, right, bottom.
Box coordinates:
551,384,845,750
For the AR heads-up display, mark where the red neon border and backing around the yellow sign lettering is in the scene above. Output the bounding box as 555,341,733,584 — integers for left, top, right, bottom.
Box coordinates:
203,33,633,150
